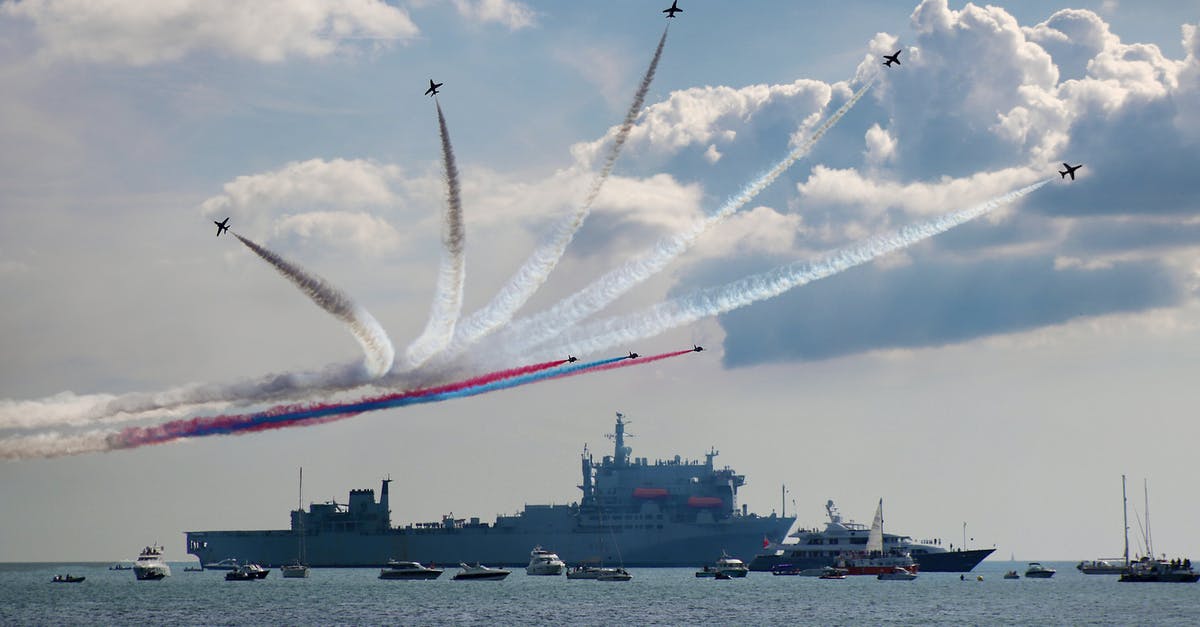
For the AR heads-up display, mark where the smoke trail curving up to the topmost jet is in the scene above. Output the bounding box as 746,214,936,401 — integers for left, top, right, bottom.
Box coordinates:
434,29,667,358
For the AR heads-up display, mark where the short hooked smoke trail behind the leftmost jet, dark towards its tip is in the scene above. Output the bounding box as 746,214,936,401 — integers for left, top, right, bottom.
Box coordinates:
233,233,396,378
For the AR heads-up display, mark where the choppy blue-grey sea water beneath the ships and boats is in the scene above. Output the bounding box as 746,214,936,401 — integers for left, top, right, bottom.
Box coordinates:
0,562,1200,626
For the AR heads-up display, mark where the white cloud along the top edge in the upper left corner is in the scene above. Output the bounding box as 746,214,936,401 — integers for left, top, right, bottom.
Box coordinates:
0,0,419,66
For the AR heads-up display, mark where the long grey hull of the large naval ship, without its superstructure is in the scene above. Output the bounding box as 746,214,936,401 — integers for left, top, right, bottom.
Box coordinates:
187,516,794,567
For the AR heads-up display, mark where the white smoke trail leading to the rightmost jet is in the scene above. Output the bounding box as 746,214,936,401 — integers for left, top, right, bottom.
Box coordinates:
534,179,1051,359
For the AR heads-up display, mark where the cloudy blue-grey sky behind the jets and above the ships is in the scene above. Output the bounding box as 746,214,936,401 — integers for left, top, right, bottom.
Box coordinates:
0,0,1200,561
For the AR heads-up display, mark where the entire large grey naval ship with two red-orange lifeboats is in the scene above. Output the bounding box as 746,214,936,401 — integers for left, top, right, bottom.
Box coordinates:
186,413,796,567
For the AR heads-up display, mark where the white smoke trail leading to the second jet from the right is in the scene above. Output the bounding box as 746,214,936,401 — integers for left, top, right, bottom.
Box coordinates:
500,77,875,348
